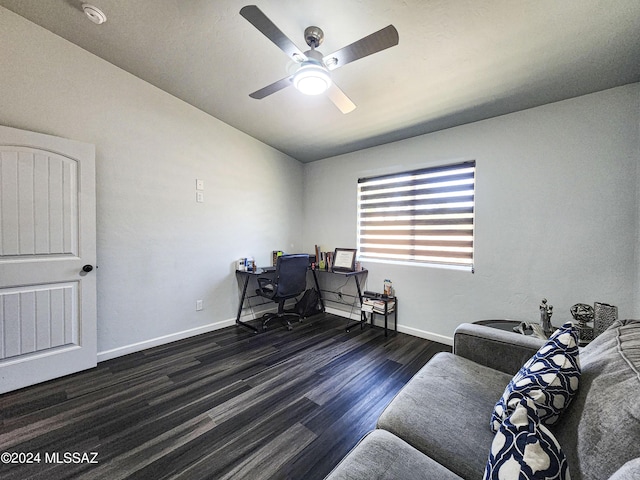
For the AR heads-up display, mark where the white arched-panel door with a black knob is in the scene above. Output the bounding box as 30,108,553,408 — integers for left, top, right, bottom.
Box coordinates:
0,126,97,393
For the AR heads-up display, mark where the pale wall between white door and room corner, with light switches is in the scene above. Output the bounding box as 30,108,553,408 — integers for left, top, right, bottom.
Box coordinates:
0,7,302,360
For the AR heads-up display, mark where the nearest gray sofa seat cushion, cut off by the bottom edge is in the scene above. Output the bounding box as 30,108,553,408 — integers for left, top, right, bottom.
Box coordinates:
325,430,462,480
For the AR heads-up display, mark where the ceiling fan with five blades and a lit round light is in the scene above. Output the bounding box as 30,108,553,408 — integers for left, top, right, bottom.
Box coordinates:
240,5,398,113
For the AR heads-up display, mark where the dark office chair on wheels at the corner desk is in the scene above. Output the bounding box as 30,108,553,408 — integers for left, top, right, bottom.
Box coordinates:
256,254,309,330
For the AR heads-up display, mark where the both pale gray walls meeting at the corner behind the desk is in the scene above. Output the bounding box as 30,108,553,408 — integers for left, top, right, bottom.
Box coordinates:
0,7,640,354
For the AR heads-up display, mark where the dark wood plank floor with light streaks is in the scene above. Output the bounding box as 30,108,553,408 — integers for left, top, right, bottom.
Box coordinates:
0,314,450,480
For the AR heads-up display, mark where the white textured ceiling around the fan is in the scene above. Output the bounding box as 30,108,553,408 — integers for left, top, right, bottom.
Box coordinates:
0,0,640,162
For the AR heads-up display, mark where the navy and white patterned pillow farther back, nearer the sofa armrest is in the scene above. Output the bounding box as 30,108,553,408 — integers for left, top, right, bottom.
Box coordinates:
490,322,580,432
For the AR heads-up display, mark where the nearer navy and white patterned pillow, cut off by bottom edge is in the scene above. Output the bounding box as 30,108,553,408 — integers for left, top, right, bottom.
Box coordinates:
483,397,569,480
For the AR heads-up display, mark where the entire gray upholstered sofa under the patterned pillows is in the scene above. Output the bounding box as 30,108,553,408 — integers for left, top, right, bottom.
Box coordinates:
327,320,640,480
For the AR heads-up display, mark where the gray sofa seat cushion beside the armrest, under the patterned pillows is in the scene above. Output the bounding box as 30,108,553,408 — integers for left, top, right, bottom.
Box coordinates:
378,352,511,478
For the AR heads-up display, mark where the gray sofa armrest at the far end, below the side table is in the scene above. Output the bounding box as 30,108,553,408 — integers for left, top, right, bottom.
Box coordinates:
453,323,545,375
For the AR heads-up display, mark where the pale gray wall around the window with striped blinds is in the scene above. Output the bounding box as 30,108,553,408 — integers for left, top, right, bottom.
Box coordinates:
304,84,640,341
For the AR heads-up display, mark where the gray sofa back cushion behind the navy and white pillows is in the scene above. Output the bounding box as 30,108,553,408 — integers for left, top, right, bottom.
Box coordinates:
551,320,640,480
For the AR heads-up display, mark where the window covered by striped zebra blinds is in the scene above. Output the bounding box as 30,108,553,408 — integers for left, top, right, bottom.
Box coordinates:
358,161,476,271
